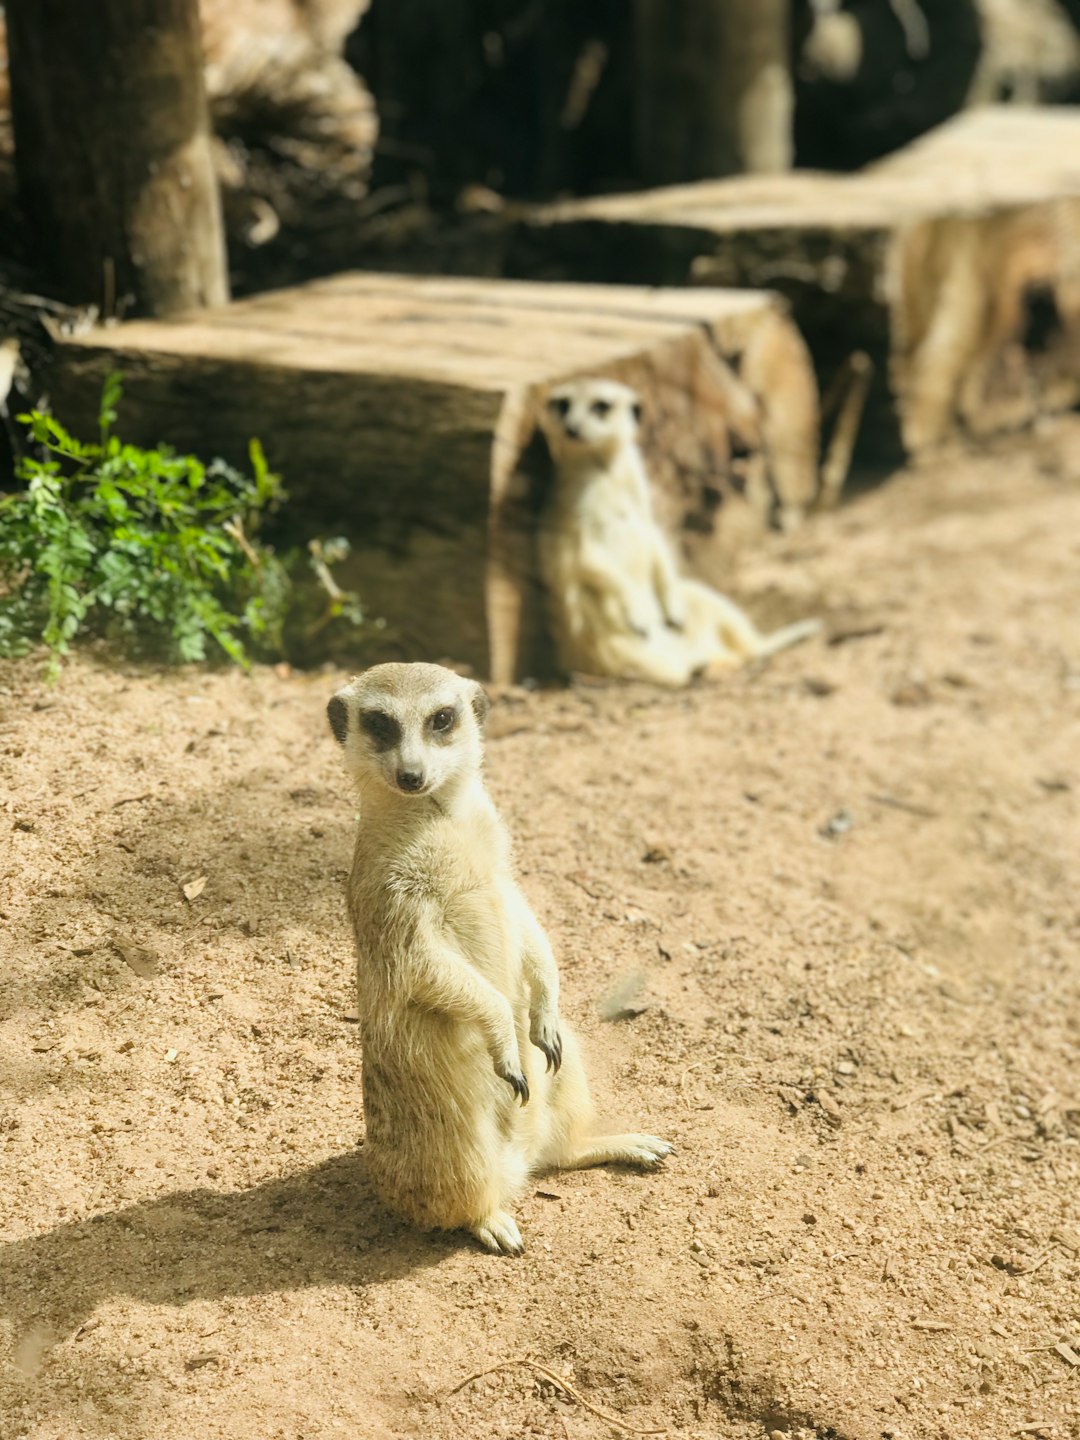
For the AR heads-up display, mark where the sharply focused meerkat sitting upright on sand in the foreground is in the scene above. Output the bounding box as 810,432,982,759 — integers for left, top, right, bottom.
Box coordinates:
327,664,671,1254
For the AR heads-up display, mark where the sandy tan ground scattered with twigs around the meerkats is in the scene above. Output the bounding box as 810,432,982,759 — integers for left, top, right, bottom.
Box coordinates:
0,432,1080,1440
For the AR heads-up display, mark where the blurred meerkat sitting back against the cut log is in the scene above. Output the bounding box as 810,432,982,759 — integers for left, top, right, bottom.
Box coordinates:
539,380,821,687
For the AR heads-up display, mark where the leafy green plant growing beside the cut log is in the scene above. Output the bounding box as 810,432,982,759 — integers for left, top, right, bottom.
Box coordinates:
0,374,360,672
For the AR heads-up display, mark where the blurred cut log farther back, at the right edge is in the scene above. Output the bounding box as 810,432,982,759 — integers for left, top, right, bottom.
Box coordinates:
505,108,1080,459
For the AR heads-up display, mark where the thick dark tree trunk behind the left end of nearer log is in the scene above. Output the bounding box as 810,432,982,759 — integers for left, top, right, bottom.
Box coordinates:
4,0,229,315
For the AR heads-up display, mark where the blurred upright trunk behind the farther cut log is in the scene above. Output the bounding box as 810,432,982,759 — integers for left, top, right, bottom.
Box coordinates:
635,0,793,184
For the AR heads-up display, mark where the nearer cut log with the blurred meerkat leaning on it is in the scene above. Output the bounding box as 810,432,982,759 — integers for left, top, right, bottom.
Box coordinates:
52,275,818,681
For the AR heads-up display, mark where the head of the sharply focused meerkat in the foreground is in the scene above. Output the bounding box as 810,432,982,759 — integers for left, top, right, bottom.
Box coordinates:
327,664,488,796
